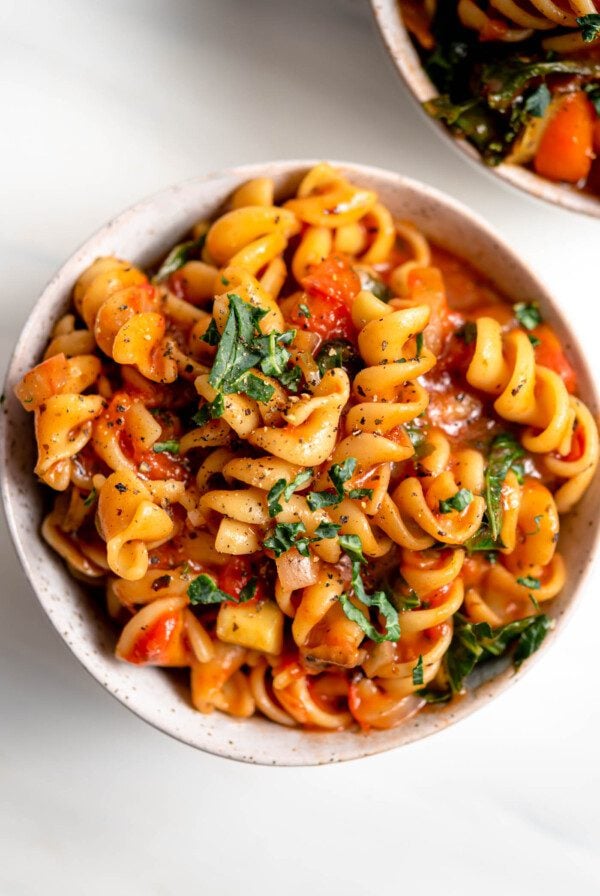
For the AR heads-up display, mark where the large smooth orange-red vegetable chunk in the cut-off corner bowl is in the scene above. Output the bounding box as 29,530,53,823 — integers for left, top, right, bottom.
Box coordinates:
534,90,595,184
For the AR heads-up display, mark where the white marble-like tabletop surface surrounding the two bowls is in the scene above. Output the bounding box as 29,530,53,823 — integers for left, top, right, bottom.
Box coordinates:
0,0,600,896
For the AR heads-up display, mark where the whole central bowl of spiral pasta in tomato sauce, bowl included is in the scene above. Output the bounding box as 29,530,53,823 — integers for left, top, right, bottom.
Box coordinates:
1,161,600,765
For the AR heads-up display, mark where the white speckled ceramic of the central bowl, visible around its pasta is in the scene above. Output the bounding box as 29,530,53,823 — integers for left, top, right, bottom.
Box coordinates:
0,161,600,765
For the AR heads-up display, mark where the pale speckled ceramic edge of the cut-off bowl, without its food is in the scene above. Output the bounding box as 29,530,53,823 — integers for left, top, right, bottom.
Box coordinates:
370,0,600,218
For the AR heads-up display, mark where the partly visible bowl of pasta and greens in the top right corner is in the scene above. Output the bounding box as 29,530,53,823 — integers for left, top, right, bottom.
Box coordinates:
371,0,600,217
